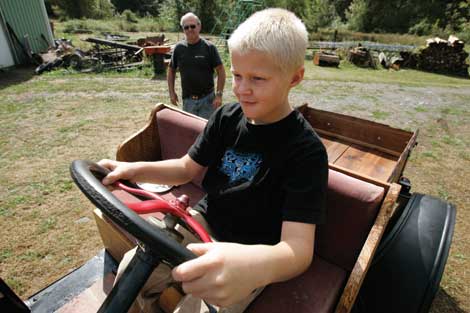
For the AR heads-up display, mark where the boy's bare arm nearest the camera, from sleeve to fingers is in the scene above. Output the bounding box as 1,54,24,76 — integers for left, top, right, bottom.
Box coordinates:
173,222,315,307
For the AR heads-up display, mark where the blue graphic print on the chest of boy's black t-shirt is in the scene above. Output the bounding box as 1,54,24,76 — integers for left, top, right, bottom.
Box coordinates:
220,149,262,185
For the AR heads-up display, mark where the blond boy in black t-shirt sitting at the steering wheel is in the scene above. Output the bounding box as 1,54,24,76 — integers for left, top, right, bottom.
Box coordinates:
100,9,328,313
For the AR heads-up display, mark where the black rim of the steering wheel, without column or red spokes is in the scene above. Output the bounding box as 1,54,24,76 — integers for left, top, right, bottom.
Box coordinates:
70,160,196,266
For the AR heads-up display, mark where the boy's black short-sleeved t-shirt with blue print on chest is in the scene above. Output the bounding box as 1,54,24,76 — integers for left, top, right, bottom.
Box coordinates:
188,103,328,244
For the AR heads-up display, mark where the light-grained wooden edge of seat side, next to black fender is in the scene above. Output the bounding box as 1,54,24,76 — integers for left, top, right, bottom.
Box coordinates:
335,183,401,313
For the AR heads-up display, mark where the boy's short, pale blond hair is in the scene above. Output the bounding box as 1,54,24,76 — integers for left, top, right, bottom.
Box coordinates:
228,9,308,72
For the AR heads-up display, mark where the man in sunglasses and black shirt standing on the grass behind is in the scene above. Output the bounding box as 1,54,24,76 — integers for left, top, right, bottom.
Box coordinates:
167,12,225,119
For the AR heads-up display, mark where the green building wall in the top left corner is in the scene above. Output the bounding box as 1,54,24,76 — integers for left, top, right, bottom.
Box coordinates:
0,0,53,63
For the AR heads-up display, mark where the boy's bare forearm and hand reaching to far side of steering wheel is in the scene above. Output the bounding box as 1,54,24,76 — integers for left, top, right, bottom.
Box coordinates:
98,154,204,185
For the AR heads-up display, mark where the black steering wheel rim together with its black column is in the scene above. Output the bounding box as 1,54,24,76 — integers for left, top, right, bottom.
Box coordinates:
70,160,196,313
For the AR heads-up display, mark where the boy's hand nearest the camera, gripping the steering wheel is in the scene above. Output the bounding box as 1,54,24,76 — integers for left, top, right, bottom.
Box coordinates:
172,242,264,307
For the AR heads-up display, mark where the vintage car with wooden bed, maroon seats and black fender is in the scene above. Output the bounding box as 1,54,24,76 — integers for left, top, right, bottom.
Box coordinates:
0,104,455,313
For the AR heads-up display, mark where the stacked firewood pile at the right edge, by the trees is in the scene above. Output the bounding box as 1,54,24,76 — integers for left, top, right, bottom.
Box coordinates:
401,36,469,77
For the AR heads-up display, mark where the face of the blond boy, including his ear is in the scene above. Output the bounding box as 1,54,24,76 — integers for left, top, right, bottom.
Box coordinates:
231,50,304,124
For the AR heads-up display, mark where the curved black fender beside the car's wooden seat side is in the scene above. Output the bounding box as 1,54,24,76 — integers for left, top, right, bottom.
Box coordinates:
353,194,456,313
